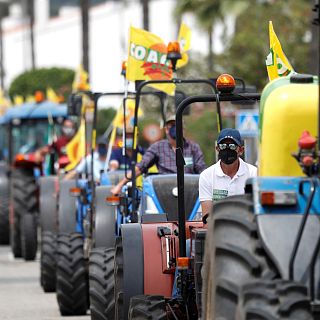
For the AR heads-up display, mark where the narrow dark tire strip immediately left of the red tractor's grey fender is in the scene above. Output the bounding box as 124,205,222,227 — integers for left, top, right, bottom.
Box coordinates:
114,237,127,320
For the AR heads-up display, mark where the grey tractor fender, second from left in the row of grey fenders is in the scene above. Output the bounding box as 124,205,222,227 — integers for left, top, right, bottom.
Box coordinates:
58,180,77,233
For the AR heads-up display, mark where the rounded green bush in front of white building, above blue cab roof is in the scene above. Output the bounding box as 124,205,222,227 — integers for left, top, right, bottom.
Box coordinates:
9,68,74,100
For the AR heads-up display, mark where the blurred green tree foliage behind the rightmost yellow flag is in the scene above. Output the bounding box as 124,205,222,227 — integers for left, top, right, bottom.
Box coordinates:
215,0,312,90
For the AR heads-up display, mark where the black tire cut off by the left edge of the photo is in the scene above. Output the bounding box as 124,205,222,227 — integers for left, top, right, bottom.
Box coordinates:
0,164,10,244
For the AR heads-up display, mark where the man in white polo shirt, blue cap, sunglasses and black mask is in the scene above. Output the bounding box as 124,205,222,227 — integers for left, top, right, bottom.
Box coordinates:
199,128,257,216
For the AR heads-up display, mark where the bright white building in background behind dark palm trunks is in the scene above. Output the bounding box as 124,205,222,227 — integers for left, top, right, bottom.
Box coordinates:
3,0,229,105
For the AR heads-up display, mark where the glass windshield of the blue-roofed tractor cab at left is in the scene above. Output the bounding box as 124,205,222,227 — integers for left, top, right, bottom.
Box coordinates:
12,119,60,155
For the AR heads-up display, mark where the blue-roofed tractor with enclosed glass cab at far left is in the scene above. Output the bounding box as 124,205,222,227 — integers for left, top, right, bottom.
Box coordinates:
2,101,66,260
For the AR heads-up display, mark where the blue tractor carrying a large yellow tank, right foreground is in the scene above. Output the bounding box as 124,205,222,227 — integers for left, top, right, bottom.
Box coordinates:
202,74,320,320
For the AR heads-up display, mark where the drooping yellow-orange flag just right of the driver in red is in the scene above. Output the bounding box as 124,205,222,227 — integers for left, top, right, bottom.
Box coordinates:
66,119,86,171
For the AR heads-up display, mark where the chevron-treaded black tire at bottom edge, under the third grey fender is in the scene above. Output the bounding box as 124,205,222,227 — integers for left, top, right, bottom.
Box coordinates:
89,248,115,320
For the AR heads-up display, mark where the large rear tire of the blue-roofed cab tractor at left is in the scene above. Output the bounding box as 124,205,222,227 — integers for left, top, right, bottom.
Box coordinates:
10,168,39,260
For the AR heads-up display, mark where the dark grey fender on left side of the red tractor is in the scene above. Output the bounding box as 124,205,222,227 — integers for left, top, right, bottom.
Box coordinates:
121,223,144,314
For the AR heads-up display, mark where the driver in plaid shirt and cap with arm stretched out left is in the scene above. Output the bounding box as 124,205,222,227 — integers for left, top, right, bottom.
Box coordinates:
111,115,206,194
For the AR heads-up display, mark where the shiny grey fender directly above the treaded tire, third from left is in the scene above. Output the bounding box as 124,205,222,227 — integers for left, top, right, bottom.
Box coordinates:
93,186,116,248
